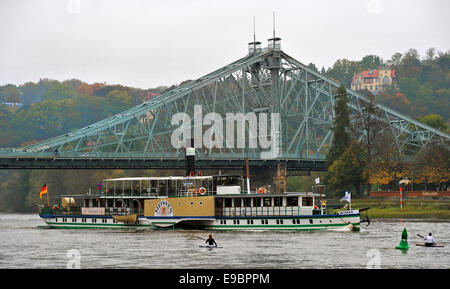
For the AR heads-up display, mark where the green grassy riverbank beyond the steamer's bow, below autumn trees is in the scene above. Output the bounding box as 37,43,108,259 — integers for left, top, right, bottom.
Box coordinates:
330,199,450,220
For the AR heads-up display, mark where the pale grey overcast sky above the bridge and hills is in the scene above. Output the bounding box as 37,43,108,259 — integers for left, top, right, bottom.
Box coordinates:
0,0,450,88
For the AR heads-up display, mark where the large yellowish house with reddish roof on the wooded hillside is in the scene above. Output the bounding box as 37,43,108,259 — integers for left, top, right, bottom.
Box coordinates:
351,69,397,94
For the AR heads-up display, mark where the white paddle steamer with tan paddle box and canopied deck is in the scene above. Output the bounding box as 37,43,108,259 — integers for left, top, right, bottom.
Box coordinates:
39,175,368,230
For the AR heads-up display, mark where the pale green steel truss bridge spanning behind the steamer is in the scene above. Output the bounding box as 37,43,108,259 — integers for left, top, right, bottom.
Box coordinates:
0,38,450,170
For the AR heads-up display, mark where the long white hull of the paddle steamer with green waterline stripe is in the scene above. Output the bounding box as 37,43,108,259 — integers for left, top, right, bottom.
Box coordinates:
41,212,360,231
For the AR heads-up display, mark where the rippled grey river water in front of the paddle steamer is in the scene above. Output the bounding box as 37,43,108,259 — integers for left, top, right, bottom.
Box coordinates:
0,214,450,269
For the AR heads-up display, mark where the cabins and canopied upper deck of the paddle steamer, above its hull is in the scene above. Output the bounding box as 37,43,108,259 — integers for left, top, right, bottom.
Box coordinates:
51,175,325,216
